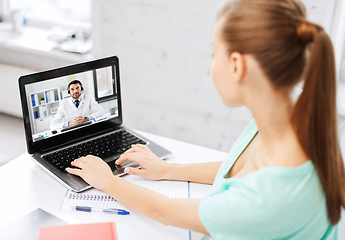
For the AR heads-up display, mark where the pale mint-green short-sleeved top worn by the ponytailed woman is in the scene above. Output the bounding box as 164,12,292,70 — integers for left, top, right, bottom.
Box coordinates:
199,120,337,240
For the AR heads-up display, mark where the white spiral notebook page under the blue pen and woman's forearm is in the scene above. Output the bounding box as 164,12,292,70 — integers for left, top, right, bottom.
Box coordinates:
61,175,189,240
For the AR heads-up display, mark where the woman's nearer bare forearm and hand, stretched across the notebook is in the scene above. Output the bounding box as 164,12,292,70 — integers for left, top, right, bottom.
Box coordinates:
66,155,207,234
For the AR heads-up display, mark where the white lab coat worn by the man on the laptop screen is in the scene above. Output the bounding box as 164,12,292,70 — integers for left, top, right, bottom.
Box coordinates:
50,94,104,130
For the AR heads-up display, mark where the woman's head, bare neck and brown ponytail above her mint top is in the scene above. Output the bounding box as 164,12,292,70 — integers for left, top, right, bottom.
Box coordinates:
212,0,345,229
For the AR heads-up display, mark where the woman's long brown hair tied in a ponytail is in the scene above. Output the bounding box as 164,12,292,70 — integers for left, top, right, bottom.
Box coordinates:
218,0,345,225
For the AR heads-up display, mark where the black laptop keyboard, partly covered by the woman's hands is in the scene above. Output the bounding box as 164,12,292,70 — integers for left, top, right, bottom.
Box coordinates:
42,130,146,171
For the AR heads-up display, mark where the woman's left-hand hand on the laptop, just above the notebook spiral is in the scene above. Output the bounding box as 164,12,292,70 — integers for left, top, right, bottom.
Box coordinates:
66,155,114,191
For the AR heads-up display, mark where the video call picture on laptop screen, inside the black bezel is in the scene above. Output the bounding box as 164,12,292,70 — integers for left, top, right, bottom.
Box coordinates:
25,67,119,142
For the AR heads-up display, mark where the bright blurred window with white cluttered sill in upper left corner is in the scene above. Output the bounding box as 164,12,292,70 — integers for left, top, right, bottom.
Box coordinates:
0,0,93,54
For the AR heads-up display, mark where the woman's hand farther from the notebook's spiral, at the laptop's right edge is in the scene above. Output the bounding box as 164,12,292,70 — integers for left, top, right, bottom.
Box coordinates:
116,144,168,180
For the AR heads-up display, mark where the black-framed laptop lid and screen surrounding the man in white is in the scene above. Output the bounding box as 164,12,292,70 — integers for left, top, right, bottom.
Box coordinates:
19,56,122,154
